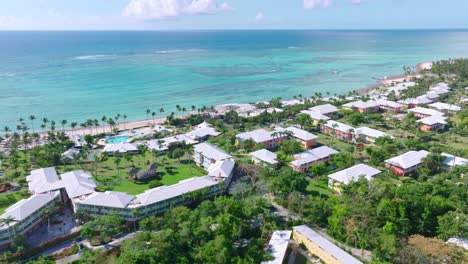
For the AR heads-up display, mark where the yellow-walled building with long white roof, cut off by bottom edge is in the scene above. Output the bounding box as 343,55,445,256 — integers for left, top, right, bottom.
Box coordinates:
293,225,362,264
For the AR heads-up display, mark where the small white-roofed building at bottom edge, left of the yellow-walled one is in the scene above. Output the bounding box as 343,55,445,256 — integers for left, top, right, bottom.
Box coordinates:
261,230,292,264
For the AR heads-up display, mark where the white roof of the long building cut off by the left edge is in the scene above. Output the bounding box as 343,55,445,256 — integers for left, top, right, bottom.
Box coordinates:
0,191,60,228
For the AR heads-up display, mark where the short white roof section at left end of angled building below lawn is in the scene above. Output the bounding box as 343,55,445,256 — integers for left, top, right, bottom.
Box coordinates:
75,191,135,208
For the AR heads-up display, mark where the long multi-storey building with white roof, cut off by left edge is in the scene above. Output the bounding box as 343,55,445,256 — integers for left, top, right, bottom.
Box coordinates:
0,191,60,249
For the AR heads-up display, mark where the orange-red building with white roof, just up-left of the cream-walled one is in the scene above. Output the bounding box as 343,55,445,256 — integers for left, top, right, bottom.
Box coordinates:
289,146,338,172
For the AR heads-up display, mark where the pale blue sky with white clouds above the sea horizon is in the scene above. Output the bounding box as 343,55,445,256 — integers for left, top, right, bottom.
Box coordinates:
0,0,468,30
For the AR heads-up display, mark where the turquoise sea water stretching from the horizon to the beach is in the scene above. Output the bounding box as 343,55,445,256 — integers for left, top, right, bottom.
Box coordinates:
0,30,468,130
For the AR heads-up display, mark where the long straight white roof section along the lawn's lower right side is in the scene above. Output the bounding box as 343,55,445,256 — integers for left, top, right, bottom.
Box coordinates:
133,176,218,206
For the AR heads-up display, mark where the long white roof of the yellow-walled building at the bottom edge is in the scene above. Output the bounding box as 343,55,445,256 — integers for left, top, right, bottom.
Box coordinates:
293,225,362,264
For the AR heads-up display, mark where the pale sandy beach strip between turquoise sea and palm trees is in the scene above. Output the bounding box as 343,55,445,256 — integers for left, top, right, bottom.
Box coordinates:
1,62,432,137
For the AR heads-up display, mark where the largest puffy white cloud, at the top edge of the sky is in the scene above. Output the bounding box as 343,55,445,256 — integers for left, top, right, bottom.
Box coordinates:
123,0,233,20
